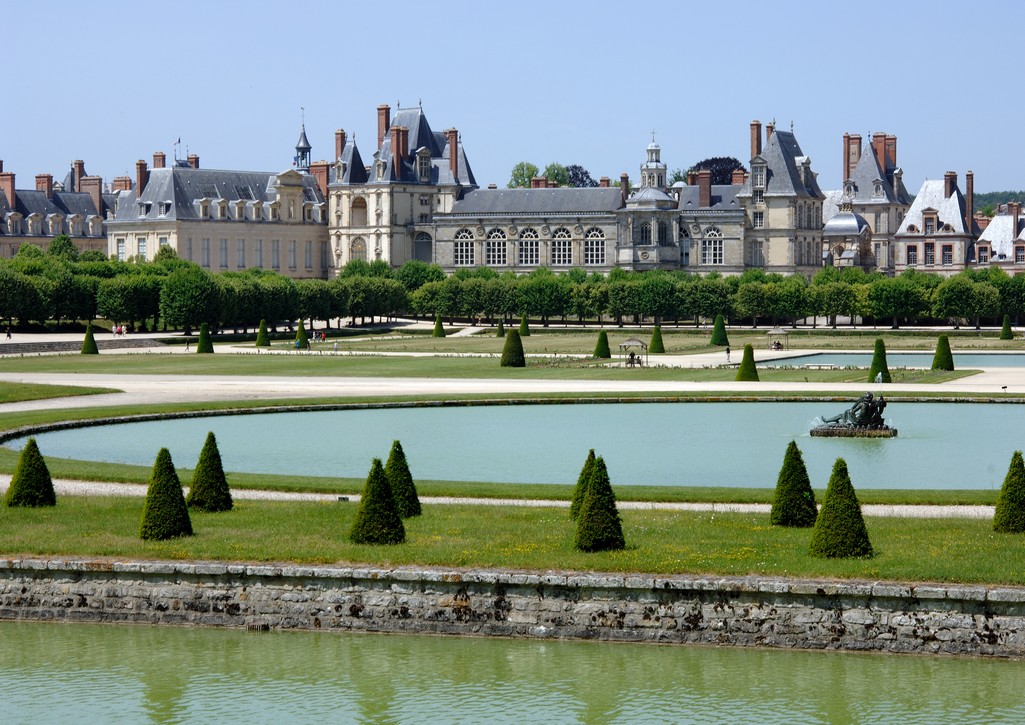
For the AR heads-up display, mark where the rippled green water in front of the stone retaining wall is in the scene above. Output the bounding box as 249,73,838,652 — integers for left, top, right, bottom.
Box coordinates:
0,622,1025,725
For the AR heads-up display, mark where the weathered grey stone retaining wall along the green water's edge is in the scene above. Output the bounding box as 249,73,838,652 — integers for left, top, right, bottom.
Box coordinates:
0,559,1025,656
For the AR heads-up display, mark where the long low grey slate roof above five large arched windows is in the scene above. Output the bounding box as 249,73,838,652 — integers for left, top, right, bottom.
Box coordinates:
449,187,623,215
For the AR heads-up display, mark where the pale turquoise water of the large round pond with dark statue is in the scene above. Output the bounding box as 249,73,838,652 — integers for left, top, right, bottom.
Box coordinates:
9,399,1025,489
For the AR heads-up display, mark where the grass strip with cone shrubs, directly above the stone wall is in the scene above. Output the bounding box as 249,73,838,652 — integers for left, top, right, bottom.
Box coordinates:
0,496,1025,585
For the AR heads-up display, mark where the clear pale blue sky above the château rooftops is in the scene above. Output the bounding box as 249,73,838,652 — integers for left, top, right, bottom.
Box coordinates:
0,0,1025,194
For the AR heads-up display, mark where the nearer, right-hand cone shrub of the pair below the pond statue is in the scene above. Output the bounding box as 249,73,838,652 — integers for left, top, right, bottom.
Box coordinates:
808,458,872,559
